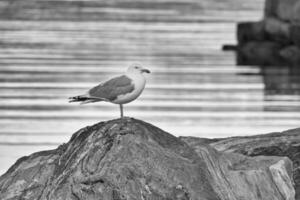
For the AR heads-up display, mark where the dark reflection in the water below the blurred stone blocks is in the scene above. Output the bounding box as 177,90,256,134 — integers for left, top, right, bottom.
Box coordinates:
237,66,300,114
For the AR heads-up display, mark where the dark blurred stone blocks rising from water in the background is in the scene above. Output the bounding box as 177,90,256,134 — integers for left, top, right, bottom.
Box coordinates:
226,0,300,65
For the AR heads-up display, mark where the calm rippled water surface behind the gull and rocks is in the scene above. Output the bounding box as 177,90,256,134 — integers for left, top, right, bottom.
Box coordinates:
0,0,300,173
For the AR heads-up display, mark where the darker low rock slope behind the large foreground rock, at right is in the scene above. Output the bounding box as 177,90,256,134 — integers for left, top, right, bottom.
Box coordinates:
181,129,300,200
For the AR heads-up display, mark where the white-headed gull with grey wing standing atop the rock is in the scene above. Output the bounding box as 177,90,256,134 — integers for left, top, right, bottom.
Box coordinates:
69,63,150,118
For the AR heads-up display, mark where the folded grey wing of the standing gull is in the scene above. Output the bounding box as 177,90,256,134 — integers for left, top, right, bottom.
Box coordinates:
88,75,134,101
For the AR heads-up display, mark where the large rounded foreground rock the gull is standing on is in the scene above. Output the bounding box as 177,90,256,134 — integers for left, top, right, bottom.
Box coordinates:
0,118,294,200
